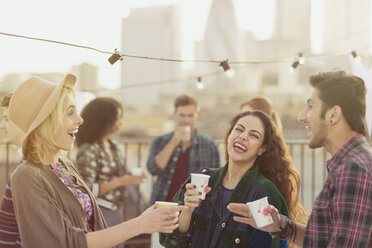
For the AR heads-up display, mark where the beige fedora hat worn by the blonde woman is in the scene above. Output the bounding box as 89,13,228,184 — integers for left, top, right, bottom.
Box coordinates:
9,74,76,151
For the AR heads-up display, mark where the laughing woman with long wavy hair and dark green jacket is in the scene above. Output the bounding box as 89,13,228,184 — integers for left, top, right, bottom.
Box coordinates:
161,111,306,248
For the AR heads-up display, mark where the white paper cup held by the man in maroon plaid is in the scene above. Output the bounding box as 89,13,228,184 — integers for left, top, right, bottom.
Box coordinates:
247,196,273,228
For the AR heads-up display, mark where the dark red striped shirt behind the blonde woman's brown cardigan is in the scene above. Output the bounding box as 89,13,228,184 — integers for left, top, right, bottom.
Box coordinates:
0,181,21,248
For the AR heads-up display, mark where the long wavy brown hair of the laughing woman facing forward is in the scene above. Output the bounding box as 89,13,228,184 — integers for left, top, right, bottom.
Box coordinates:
225,111,308,224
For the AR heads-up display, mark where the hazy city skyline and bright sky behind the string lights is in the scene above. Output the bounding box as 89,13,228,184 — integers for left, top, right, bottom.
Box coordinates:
0,0,371,128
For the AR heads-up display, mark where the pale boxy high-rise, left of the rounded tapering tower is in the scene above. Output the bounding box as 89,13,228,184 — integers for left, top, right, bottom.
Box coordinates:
121,6,181,104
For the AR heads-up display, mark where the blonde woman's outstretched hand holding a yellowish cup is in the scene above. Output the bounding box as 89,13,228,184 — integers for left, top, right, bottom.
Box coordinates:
136,205,187,233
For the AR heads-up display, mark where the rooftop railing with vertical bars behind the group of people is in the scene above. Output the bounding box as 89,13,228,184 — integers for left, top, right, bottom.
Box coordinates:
0,139,330,215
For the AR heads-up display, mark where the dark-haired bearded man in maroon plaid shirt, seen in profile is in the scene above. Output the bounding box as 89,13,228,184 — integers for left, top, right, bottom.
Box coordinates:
229,71,372,248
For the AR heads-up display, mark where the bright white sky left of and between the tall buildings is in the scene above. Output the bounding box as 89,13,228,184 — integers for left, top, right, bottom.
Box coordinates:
0,0,275,88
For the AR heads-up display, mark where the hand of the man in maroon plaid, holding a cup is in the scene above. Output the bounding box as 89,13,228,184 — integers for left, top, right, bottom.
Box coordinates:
227,203,282,232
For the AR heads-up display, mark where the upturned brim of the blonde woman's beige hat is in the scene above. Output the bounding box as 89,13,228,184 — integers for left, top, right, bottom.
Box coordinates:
22,74,76,151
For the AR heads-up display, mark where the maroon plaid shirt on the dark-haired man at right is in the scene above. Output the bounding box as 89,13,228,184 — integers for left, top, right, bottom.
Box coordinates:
303,135,372,248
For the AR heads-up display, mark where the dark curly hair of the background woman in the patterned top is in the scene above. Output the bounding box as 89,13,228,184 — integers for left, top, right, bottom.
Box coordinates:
76,97,123,147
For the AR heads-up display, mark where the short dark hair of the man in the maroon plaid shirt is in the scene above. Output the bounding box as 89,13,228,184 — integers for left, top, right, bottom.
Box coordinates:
309,71,367,136
